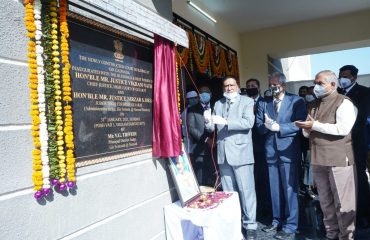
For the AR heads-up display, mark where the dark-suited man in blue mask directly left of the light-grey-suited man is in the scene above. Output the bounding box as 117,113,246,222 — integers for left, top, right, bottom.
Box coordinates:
187,86,216,186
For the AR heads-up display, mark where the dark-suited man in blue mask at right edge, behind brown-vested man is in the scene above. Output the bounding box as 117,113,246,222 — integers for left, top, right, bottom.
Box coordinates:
338,65,370,228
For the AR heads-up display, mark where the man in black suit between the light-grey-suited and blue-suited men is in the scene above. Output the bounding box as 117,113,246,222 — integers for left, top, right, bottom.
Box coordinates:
245,78,271,216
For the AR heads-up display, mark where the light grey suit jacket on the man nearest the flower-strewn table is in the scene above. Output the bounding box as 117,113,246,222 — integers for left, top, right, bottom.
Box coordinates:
207,95,254,166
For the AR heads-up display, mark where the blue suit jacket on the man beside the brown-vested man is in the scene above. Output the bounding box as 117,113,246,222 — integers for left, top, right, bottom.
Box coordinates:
256,92,307,163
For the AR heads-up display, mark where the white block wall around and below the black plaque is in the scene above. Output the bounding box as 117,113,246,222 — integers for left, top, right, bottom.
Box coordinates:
0,0,176,240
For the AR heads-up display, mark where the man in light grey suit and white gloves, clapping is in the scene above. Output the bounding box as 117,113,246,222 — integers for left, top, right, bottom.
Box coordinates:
204,77,257,240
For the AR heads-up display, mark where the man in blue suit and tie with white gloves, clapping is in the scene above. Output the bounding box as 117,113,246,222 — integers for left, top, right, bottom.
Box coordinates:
256,73,307,240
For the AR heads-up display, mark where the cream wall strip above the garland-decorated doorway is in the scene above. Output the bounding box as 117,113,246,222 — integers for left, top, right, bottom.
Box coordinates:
172,0,245,82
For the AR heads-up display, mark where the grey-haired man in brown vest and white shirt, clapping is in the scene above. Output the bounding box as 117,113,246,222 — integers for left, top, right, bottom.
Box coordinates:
296,70,358,239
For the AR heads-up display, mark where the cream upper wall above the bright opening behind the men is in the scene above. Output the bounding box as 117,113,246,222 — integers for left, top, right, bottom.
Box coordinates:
240,10,370,88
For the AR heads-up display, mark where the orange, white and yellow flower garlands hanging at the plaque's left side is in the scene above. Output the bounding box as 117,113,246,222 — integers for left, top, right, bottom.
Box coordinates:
24,0,76,199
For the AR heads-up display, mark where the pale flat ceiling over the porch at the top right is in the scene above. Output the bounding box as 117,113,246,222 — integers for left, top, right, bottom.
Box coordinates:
192,0,370,32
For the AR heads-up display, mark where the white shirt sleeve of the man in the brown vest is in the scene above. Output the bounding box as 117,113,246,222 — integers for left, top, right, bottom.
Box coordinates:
303,99,357,137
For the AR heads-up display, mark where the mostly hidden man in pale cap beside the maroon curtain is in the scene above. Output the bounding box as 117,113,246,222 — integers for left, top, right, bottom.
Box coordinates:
181,91,199,154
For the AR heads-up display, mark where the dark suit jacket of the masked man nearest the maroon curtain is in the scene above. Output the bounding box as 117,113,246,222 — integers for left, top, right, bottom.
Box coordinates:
187,103,212,156
